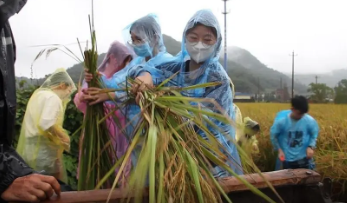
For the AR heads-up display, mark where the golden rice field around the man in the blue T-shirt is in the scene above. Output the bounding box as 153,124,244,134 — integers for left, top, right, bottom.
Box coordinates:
237,103,347,200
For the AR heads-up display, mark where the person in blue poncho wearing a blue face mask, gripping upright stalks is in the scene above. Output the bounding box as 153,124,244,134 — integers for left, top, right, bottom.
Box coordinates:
85,14,173,165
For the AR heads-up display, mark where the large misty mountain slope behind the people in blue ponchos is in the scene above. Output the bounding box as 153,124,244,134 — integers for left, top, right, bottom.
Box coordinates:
17,35,307,93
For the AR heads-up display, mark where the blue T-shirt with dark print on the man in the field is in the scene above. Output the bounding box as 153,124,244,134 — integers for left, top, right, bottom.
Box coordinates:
270,110,319,170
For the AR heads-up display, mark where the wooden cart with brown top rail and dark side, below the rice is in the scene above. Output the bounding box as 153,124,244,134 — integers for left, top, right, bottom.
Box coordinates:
21,169,338,203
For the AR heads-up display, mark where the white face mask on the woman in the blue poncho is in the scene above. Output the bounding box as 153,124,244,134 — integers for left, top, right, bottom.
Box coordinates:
186,41,215,63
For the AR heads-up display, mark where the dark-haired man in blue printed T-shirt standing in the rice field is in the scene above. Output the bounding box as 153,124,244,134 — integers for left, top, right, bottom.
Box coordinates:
270,96,319,170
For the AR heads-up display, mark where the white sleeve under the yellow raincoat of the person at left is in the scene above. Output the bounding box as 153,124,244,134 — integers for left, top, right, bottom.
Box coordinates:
39,95,63,131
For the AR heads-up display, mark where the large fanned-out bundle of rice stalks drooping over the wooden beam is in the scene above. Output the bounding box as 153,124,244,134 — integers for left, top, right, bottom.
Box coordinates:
96,77,280,203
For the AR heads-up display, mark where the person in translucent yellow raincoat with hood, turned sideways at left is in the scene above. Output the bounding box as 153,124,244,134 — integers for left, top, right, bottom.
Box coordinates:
17,68,76,181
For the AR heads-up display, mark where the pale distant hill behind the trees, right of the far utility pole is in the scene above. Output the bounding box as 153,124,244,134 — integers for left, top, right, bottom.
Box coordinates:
295,69,347,87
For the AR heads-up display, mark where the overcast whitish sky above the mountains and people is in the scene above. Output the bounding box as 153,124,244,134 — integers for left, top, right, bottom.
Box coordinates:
10,0,347,77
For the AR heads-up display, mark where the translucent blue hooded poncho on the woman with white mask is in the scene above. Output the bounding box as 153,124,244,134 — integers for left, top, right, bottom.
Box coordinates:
134,10,242,178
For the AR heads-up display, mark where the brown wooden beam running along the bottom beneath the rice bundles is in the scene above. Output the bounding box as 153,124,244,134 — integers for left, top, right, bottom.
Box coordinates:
29,169,321,203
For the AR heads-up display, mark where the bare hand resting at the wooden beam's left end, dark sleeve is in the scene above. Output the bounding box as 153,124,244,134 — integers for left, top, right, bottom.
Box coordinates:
1,174,61,202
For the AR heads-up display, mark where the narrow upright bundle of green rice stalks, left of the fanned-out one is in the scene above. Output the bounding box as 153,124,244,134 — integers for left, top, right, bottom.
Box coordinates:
78,13,116,190
